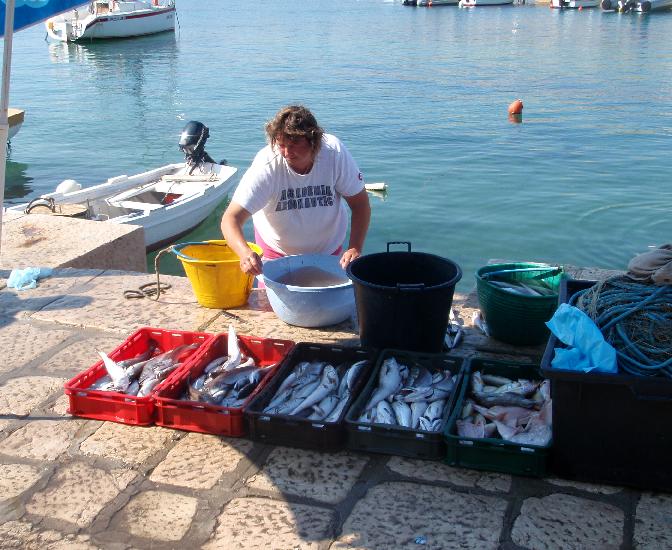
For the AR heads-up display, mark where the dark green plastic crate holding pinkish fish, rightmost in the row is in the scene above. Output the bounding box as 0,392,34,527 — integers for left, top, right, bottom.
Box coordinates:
443,358,552,477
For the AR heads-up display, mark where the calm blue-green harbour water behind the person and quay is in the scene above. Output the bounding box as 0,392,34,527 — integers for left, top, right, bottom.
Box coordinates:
5,0,672,290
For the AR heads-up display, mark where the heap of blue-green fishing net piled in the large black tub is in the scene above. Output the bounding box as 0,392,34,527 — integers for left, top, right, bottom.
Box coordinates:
570,276,672,378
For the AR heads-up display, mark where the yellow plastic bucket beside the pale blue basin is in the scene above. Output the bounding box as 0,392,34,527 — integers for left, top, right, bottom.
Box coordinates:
173,240,262,309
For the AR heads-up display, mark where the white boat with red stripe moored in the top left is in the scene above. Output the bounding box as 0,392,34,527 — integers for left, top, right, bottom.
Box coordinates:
45,0,175,42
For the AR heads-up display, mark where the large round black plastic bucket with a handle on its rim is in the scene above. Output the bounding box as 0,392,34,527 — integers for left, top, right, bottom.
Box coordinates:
347,242,462,353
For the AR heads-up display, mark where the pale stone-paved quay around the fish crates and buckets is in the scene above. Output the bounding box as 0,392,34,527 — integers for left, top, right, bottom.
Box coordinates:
0,269,672,550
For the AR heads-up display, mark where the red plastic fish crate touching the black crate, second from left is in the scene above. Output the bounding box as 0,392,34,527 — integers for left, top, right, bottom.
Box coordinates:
155,333,294,437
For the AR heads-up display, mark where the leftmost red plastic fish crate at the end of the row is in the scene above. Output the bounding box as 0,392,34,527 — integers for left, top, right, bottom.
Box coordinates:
65,327,213,426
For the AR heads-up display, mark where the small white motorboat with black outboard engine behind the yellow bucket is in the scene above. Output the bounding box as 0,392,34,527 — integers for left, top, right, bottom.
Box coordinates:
7,121,237,250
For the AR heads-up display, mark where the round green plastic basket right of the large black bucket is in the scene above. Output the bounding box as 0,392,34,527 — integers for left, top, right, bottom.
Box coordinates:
476,262,563,346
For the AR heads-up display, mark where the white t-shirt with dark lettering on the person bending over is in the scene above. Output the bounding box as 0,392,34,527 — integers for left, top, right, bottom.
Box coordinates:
232,134,364,255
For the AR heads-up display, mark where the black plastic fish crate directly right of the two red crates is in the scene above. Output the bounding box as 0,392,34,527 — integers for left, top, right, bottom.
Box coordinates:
244,342,378,451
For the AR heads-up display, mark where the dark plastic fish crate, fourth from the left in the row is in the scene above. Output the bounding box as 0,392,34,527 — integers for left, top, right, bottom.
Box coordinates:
345,349,464,460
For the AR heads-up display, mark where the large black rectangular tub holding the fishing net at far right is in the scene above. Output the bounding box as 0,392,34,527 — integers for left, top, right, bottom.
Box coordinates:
541,279,672,491
